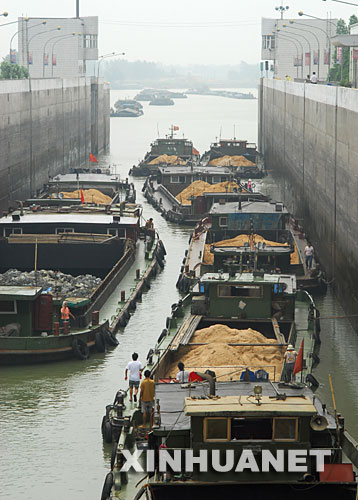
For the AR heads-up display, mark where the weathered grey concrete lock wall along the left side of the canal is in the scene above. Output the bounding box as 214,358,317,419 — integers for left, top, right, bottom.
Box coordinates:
0,78,110,210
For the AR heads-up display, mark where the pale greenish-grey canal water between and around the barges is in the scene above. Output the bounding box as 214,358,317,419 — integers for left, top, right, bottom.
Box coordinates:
0,91,358,500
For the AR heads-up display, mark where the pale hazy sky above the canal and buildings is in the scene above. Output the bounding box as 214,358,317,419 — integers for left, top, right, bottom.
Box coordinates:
0,0,358,64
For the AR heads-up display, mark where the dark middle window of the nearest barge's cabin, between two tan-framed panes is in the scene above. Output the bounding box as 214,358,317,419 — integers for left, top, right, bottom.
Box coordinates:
231,418,272,441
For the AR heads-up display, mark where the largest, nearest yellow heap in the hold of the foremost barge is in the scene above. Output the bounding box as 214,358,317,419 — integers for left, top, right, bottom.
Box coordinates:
168,324,285,381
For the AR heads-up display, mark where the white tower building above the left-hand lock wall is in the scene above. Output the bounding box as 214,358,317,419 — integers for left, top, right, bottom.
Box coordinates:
18,16,98,78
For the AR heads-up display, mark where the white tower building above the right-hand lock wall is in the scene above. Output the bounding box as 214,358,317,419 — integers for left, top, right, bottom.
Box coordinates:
261,18,337,80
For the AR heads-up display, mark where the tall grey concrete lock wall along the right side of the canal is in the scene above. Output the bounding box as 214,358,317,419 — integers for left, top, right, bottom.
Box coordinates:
259,79,358,327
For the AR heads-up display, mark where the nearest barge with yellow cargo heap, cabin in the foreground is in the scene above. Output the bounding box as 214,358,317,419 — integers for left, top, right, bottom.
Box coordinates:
98,273,358,500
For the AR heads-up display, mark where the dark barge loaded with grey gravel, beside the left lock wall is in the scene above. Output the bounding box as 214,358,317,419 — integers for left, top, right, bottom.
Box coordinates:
0,180,165,365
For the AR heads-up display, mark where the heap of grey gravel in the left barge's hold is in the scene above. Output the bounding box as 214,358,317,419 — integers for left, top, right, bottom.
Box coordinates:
0,269,102,297
